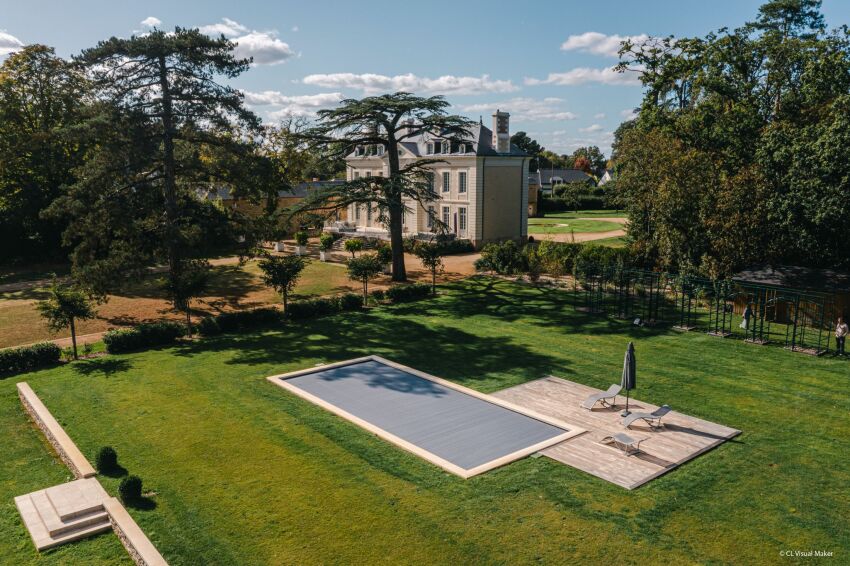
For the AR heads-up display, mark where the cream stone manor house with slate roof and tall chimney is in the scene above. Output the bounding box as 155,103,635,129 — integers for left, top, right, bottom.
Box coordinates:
346,111,530,247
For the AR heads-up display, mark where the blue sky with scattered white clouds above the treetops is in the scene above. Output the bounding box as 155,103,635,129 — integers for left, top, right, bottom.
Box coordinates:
0,0,850,154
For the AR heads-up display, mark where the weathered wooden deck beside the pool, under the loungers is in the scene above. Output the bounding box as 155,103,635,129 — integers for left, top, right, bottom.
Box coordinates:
493,377,741,489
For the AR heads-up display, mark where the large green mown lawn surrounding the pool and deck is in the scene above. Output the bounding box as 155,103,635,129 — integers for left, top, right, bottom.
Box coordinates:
0,277,850,565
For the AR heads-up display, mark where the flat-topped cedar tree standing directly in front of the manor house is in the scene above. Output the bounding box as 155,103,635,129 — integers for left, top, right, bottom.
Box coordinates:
295,92,473,281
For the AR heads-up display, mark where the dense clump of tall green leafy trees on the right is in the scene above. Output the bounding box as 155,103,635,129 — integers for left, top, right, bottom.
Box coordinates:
614,0,850,276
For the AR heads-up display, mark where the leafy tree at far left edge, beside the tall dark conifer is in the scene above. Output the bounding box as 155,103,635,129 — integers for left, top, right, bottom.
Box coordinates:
0,45,90,263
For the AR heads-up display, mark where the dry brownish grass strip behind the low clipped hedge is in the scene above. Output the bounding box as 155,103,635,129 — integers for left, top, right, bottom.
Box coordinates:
0,261,359,348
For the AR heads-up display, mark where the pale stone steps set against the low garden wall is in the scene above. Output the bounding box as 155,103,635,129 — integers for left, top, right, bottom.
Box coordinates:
15,478,112,550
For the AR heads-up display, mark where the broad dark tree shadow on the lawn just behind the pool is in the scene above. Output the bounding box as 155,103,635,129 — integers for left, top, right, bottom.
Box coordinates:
171,311,572,385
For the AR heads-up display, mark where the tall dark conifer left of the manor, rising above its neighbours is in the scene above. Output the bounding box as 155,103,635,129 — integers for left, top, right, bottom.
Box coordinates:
49,28,267,301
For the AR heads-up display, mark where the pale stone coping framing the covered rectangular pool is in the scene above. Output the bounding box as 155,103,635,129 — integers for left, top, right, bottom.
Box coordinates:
266,355,586,479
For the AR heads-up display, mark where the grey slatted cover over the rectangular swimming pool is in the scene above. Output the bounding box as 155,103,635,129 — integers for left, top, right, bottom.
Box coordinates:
286,361,566,470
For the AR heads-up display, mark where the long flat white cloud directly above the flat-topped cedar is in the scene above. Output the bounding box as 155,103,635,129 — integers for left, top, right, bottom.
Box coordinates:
301,73,518,95
